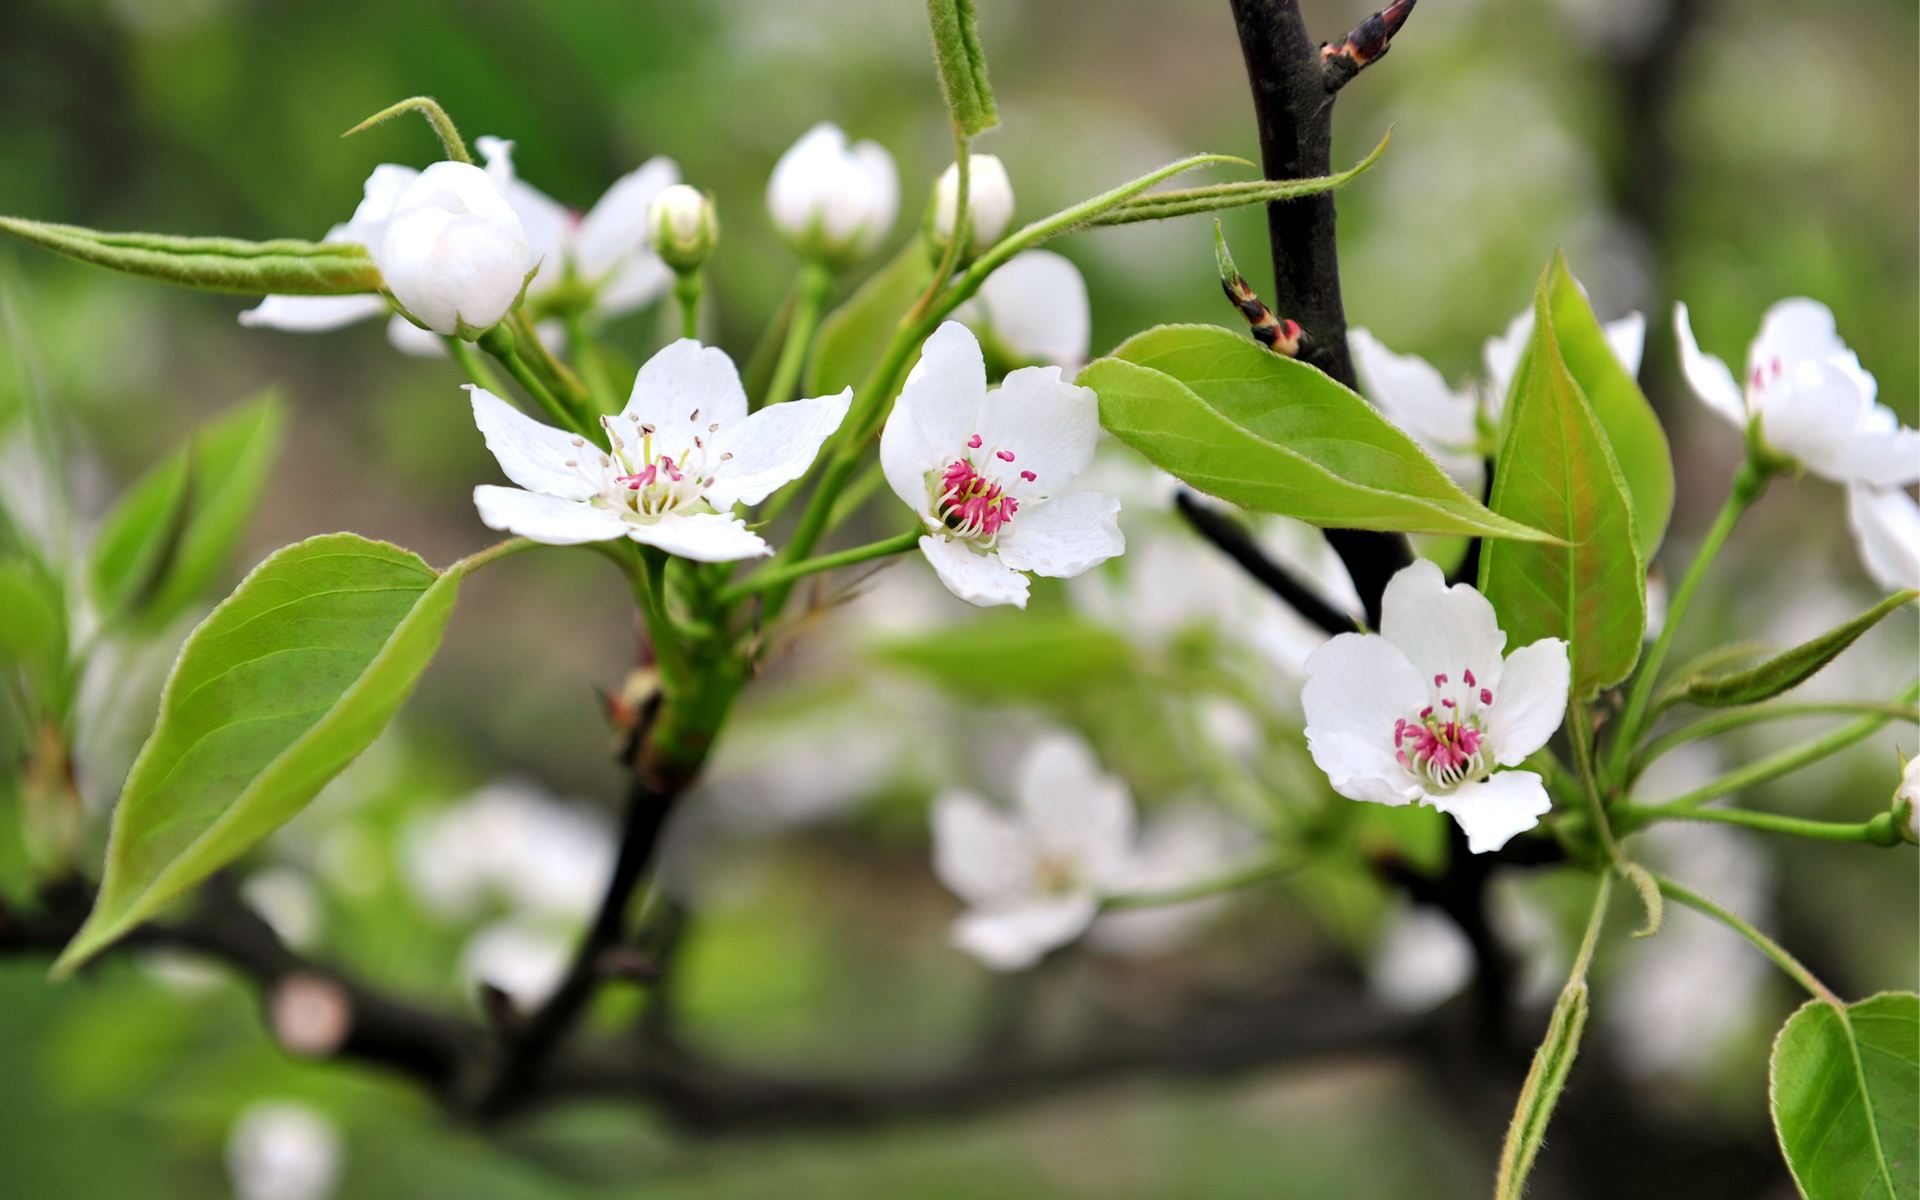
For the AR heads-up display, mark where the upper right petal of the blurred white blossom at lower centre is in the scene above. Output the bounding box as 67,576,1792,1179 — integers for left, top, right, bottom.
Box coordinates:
1014,733,1133,889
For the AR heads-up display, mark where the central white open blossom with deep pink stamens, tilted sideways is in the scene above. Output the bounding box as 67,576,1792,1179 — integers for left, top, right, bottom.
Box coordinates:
879,321,1127,607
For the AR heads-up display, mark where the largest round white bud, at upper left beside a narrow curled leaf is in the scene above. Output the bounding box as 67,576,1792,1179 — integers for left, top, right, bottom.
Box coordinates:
371,161,534,336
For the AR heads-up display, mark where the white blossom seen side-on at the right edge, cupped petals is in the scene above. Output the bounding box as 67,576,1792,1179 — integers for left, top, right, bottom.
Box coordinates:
1674,298,1920,488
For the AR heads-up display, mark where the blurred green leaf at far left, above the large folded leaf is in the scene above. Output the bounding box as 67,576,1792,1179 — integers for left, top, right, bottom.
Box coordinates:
90,394,286,628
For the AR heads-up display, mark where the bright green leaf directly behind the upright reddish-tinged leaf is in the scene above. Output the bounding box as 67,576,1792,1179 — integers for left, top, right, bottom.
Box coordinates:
1548,253,1674,563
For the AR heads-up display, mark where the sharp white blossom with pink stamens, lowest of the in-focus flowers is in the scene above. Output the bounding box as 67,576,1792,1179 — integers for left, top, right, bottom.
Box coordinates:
1300,559,1569,854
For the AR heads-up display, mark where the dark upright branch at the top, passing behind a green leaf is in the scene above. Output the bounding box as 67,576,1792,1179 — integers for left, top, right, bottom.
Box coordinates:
1231,0,1413,628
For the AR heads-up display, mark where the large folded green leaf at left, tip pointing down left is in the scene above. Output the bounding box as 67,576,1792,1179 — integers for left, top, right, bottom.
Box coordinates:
54,534,461,977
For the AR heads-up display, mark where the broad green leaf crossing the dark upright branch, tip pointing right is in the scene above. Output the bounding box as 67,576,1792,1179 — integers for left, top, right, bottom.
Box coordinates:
1079,324,1548,540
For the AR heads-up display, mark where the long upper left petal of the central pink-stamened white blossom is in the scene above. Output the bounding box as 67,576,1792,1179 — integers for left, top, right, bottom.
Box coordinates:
879,321,987,522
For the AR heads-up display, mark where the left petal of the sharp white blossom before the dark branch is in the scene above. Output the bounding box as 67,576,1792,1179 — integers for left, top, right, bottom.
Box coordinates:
1300,634,1428,804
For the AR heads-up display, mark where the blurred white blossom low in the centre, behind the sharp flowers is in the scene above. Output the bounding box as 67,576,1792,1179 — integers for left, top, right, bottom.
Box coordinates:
933,735,1133,972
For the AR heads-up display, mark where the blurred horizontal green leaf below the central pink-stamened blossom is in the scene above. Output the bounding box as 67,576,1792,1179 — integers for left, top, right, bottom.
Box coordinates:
872,612,1137,701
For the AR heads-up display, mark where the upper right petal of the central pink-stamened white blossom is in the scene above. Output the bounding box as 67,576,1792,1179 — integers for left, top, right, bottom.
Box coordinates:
973,367,1100,499
